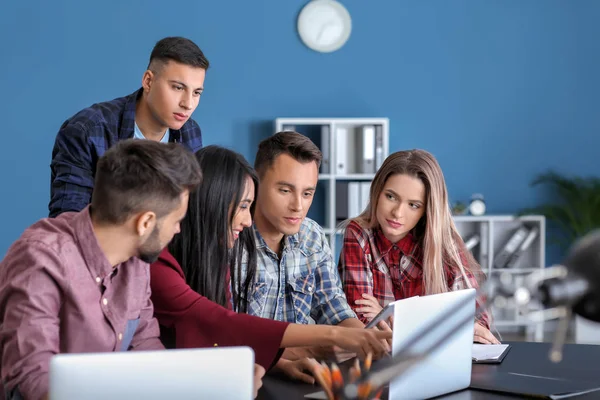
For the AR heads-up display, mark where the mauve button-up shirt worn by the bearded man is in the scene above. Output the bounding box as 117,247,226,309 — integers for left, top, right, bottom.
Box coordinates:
0,207,164,400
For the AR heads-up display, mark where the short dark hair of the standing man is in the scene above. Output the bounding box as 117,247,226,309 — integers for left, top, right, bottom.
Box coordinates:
148,36,209,70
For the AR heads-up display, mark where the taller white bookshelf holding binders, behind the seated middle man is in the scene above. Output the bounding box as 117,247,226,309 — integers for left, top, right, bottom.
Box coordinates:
274,118,390,253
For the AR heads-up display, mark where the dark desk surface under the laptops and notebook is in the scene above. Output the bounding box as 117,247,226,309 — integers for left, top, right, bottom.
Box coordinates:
258,342,600,400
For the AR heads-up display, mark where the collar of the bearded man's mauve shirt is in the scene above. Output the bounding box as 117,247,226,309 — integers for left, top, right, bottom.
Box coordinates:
73,206,118,279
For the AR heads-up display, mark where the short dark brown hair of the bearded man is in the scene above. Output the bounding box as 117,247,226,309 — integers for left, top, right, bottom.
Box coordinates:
91,139,202,224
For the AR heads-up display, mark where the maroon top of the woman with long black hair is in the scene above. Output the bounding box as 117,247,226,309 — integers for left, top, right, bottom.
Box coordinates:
150,249,288,369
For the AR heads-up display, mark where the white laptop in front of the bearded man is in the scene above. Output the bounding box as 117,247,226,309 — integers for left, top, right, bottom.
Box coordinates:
50,347,254,400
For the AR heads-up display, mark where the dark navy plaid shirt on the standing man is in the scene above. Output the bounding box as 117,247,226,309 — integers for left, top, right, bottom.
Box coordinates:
48,89,202,217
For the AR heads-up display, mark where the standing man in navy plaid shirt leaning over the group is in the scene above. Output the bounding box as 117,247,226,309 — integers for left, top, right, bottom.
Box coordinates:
48,37,209,217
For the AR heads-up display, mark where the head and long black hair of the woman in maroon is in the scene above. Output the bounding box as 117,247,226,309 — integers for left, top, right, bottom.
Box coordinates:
168,146,258,312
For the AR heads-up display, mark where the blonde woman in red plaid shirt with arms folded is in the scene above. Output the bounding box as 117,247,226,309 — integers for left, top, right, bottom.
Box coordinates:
338,150,499,344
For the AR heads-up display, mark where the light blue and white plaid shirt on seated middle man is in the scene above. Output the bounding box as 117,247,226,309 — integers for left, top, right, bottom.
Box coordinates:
240,218,356,325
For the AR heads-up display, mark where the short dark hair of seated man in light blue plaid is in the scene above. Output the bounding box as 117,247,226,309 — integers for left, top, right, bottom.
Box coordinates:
254,131,323,177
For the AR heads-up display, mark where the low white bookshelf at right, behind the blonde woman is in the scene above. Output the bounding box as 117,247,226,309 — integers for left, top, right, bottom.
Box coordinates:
454,215,546,342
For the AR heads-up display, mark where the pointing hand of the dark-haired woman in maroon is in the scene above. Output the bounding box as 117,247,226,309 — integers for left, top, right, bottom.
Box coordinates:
333,327,392,359
